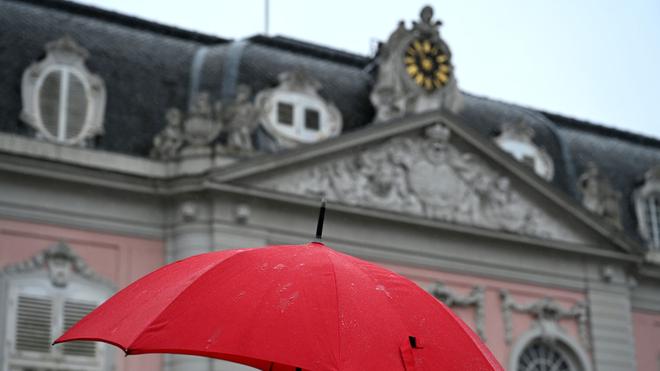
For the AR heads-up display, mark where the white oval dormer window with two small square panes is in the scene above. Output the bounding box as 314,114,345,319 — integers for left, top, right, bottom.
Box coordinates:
255,71,342,147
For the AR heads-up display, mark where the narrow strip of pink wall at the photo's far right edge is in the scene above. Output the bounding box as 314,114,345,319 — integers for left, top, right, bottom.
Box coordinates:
633,311,660,371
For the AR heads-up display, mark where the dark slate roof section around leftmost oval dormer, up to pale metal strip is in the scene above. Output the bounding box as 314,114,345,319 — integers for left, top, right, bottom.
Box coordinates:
0,0,225,155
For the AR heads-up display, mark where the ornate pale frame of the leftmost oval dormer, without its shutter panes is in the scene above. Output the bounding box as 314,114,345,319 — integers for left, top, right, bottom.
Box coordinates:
21,37,106,145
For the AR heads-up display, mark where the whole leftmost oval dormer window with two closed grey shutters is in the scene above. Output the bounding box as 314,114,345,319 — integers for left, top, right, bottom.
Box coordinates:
21,37,105,144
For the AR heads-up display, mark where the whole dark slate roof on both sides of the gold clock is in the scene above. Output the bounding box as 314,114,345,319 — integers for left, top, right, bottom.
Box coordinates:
0,0,660,250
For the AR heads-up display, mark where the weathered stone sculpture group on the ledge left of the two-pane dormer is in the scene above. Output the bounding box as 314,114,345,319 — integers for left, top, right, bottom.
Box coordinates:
151,85,259,160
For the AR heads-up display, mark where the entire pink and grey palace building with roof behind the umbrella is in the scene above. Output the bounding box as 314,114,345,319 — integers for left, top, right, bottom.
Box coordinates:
0,0,660,371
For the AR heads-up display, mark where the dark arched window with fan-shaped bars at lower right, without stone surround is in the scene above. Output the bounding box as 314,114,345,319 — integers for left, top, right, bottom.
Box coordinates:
516,340,581,371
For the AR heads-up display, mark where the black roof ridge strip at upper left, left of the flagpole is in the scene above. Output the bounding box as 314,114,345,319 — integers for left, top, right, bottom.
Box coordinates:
7,0,231,45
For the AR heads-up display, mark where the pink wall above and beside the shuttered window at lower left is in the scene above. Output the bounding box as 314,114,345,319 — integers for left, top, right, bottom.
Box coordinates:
0,219,164,371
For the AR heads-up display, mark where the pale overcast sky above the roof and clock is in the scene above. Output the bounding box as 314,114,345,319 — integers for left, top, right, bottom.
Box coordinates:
79,0,660,138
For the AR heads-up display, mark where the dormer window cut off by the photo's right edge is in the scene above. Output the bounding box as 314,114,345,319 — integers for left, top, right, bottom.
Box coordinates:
634,166,660,254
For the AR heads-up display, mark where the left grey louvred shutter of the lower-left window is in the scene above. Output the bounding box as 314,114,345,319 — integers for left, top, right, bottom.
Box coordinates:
16,296,52,353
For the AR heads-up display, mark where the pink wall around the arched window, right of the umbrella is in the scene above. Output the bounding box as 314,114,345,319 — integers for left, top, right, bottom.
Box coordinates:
387,265,587,368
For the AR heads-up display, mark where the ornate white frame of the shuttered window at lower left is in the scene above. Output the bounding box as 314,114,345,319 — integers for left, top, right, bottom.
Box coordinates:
0,243,114,371
